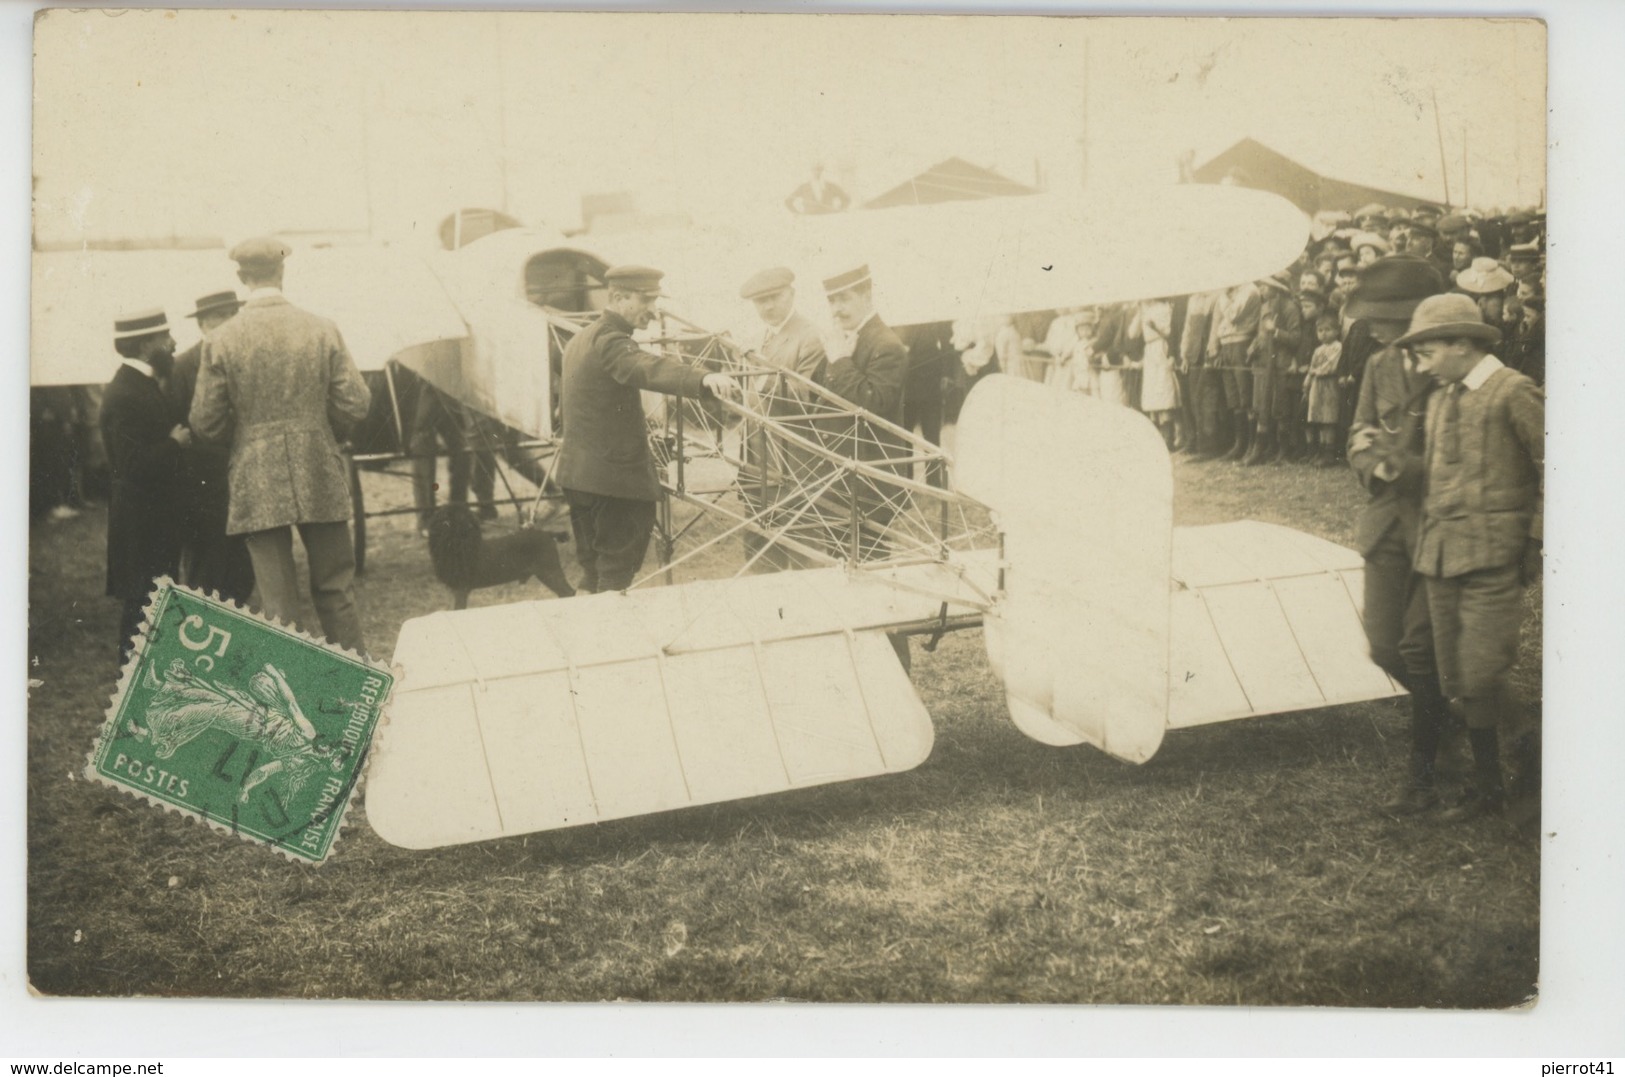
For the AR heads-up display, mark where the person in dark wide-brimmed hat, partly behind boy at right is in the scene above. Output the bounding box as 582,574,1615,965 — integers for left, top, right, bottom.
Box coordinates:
1346,255,1448,815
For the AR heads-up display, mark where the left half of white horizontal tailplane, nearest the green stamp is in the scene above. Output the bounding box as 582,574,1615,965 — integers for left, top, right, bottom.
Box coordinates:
367,562,995,848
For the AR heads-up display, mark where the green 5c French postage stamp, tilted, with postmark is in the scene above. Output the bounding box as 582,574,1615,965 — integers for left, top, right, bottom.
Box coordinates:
85,580,395,864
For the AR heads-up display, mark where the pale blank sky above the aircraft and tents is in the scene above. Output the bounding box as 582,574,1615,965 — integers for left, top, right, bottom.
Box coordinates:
34,10,1545,244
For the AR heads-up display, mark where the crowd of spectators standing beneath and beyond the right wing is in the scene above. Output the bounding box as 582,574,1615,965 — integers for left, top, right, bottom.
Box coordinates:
947,205,1545,468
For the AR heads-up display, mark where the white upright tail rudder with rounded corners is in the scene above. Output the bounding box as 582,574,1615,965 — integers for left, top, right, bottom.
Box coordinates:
956,375,1173,763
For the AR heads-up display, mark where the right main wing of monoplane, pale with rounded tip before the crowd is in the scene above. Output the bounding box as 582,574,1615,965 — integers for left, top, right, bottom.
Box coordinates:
633,184,1310,328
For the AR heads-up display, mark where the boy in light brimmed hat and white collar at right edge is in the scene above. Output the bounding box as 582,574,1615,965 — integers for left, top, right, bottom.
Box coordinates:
1394,294,1545,820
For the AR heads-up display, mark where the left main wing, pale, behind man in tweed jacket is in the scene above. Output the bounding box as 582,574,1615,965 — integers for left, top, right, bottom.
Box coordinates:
29,245,468,385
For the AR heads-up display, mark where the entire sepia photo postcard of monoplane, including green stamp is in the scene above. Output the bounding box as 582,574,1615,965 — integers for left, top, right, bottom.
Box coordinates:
26,8,1578,1010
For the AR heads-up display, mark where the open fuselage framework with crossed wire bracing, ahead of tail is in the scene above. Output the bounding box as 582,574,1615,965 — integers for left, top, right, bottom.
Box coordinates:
548,303,998,586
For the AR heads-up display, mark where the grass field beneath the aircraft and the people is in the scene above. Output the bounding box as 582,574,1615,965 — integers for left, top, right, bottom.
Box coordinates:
28,451,1541,1007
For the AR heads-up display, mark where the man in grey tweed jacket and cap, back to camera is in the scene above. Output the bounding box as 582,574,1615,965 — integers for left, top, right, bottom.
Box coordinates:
192,237,372,653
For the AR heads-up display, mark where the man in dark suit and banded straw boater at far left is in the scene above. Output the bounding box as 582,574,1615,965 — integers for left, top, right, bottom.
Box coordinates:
101,307,192,664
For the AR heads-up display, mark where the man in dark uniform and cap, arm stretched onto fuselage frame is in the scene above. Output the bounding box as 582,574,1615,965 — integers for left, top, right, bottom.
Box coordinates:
557,265,739,591
